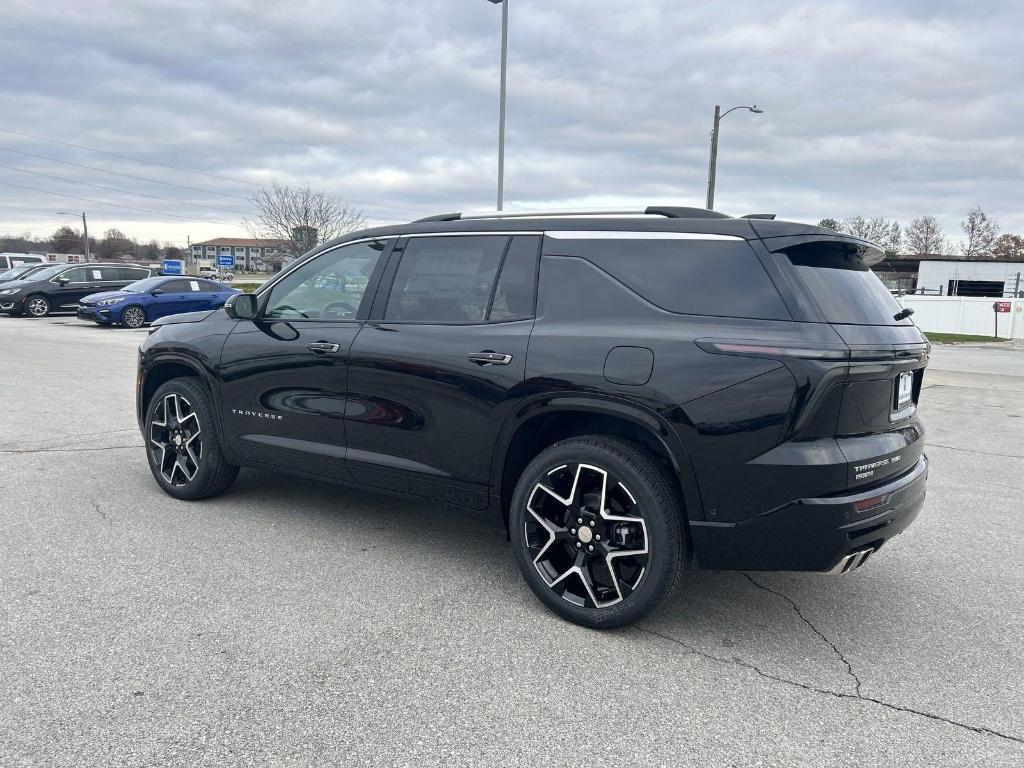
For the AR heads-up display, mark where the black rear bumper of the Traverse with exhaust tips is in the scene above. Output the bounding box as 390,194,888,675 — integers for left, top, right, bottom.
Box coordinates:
690,456,928,572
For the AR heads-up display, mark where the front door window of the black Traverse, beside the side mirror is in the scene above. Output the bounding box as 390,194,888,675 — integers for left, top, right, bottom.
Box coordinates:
263,240,387,321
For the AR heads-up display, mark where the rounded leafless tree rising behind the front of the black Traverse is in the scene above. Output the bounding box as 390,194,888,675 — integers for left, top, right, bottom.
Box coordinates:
243,183,366,264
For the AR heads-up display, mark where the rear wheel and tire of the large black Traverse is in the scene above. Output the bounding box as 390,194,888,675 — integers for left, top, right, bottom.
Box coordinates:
509,435,686,629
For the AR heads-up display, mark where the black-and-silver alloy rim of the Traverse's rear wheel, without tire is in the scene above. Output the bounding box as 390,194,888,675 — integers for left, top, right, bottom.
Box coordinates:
525,464,648,608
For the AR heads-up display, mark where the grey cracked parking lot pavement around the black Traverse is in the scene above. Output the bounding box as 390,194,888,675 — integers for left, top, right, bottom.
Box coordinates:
0,317,1024,767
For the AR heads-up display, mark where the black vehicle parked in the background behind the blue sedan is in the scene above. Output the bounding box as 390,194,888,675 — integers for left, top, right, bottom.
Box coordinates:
0,262,154,317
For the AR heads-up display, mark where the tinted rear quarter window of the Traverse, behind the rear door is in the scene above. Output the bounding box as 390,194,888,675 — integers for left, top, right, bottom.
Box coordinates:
545,232,791,319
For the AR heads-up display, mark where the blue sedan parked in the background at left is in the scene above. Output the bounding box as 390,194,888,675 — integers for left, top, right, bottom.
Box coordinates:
78,276,242,328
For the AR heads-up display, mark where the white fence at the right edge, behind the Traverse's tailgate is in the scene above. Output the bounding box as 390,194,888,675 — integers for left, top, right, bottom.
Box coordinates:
898,295,1024,339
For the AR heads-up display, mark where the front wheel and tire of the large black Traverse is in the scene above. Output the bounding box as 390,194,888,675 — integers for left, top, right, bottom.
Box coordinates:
143,377,239,500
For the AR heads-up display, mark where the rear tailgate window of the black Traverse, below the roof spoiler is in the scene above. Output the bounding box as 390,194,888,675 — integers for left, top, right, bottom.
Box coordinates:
783,242,912,326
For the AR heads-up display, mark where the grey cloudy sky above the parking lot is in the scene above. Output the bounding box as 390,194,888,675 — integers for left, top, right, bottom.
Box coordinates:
0,0,1024,243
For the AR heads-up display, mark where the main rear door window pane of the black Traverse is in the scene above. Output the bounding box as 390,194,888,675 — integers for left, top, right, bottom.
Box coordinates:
384,234,509,323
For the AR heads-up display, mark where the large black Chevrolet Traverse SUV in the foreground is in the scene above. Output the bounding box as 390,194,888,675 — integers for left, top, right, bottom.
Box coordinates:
137,208,929,627
